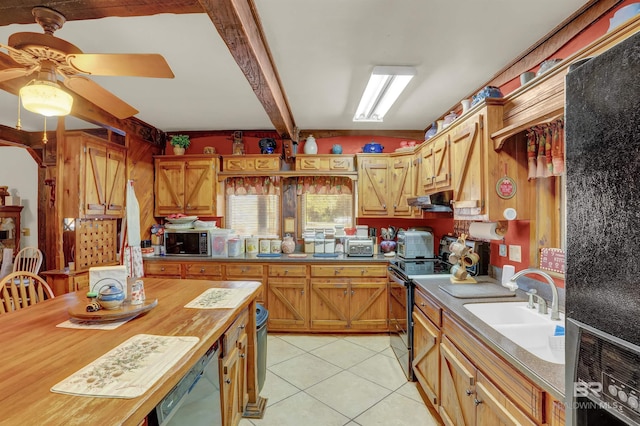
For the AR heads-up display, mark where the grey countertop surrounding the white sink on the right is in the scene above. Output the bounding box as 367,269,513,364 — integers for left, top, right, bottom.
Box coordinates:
414,275,565,401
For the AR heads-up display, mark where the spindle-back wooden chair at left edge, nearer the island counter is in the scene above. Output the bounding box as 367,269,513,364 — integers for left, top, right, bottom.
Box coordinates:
0,271,55,314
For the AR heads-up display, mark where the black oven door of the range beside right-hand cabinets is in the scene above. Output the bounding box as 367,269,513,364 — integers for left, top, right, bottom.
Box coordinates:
389,267,413,380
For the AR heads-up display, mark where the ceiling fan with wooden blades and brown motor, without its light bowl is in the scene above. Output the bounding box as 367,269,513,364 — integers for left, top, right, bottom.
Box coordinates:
0,6,174,119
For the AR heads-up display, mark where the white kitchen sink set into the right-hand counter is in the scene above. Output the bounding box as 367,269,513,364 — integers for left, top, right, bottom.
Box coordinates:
464,302,564,364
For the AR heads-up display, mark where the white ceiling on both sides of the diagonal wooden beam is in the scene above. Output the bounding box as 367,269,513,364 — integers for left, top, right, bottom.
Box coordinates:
0,0,586,132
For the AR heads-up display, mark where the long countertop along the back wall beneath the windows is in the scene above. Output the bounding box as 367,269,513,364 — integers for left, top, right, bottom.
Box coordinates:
142,253,396,263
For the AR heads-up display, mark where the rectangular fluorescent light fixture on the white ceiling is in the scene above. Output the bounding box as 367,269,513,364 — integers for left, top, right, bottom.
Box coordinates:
353,66,416,122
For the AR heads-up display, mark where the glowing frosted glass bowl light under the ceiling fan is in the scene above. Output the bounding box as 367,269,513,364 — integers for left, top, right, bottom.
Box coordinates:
20,80,73,117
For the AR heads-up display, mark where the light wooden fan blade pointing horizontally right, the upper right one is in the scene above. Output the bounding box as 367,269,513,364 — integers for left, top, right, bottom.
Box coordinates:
67,53,174,78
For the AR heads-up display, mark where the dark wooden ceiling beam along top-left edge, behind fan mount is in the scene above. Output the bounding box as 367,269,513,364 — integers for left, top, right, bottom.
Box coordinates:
0,0,202,26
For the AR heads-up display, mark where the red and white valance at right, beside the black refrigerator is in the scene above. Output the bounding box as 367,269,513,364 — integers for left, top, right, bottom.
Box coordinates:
527,119,564,180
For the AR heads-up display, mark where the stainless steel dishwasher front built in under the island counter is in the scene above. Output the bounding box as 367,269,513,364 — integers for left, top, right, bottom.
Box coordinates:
149,342,222,426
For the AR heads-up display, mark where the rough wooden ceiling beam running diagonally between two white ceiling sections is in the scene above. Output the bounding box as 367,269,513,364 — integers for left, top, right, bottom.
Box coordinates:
198,0,295,139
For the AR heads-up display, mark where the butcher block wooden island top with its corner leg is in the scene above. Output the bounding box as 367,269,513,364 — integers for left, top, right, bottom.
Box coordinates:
0,278,265,425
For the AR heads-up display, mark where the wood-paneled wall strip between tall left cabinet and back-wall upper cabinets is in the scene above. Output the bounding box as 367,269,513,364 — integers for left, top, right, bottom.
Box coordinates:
126,135,162,240
